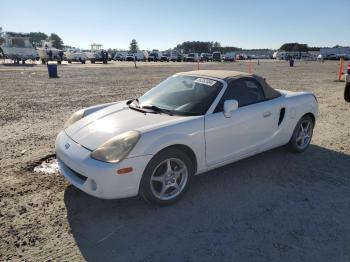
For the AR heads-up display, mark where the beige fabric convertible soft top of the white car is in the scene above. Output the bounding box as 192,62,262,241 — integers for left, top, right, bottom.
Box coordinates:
177,70,281,99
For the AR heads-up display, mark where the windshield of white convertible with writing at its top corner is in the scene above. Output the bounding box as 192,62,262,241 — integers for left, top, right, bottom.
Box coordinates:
138,76,222,116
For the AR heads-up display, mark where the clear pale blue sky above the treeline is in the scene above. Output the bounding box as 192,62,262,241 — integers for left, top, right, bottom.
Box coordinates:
0,0,350,50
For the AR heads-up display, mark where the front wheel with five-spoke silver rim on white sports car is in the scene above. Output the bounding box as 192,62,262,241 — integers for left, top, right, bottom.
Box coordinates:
139,148,195,206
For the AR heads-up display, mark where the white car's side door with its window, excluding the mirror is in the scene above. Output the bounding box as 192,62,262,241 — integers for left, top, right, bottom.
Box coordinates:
205,77,276,166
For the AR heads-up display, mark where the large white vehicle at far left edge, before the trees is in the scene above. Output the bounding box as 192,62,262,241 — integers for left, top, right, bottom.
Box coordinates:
0,32,39,63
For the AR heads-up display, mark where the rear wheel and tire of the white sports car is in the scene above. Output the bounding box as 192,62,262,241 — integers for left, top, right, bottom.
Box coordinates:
288,115,315,153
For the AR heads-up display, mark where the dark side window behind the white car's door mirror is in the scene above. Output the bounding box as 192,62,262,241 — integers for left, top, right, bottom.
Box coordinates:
214,78,265,113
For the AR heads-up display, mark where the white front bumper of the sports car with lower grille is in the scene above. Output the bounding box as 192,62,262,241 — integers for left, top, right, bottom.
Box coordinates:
56,131,152,199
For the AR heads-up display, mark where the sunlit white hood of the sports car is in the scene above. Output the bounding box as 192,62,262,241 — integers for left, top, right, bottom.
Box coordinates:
65,101,192,150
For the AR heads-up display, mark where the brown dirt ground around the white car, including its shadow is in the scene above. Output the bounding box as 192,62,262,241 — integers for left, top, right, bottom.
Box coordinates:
0,61,350,261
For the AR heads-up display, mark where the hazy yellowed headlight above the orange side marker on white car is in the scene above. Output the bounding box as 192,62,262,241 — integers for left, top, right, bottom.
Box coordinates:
90,131,141,163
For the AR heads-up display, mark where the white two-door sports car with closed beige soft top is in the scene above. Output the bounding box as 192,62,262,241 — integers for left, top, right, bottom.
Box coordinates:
56,70,318,205
